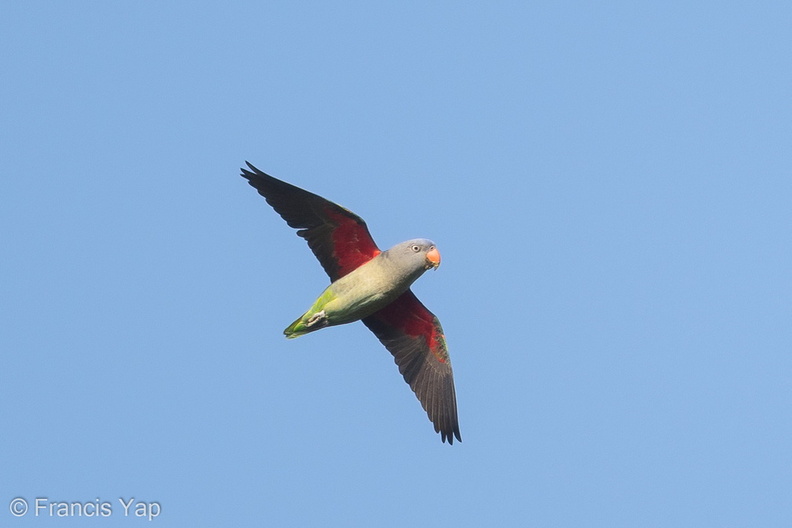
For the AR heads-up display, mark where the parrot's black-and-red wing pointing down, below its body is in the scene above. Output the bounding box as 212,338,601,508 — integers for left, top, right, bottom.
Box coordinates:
363,290,462,444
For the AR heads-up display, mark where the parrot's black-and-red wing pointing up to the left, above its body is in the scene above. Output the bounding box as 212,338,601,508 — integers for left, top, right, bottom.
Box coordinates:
242,162,380,281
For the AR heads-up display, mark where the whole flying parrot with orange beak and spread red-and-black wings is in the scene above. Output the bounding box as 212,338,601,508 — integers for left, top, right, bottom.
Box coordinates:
241,161,462,445
